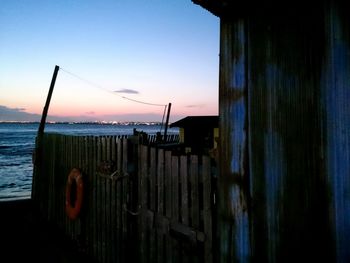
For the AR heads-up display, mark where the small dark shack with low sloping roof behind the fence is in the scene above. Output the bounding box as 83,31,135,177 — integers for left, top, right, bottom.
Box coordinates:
170,116,219,154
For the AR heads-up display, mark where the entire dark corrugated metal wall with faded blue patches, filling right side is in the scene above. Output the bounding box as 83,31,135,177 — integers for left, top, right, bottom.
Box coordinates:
195,0,350,262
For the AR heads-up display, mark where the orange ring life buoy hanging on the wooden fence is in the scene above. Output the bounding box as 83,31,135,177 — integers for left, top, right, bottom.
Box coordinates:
66,168,84,220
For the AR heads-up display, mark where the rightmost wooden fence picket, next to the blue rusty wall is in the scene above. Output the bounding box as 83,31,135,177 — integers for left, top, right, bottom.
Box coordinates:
202,156,213,263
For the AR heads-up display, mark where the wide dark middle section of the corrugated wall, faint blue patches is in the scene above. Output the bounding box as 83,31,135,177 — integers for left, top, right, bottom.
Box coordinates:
247,6,333,262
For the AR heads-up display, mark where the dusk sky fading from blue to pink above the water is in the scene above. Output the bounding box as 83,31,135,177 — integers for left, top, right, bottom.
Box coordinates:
0,0,219,124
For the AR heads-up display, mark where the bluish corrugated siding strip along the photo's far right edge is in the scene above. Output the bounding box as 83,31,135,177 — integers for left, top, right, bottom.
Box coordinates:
322,4,350,262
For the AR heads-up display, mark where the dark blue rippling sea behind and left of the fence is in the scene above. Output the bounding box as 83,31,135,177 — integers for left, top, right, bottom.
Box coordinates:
0,122,178,202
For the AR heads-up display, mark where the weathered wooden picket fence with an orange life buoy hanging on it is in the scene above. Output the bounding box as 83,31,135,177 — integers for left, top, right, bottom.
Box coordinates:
32,134,216,263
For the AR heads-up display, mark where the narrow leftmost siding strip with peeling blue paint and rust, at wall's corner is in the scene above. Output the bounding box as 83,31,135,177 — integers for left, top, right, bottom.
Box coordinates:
219,19,250,262
